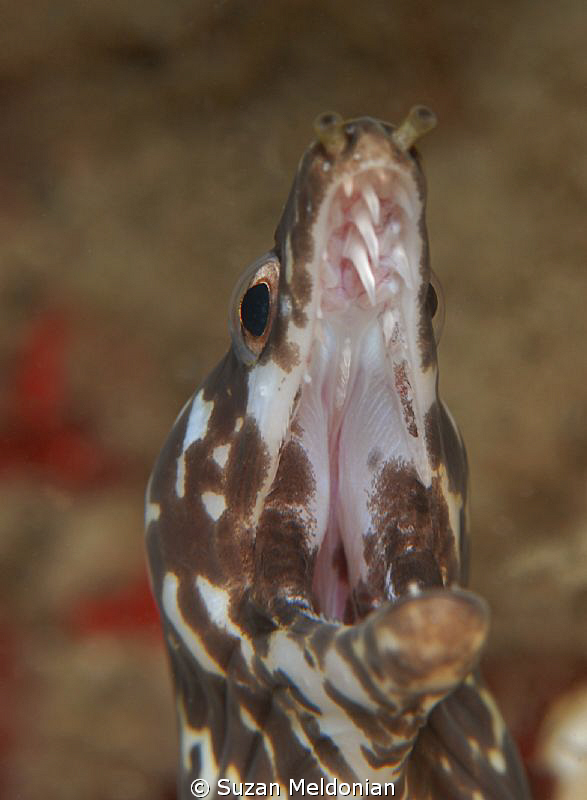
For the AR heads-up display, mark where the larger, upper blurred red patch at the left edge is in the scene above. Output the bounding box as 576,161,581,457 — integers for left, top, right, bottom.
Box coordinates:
0,311,127,491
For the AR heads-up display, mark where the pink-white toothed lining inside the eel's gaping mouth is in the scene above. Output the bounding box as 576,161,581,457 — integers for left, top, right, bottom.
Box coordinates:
288,170,419,622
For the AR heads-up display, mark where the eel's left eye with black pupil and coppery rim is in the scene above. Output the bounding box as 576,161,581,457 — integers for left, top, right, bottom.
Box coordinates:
230,252,280,365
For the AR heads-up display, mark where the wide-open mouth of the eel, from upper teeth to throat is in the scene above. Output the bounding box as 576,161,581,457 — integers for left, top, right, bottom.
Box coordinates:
290,167,431,622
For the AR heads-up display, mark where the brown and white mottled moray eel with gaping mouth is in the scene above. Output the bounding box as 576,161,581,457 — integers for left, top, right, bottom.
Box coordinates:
146,106,529,800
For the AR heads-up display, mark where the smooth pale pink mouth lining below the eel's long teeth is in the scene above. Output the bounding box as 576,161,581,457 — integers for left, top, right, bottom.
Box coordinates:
294,309,422,616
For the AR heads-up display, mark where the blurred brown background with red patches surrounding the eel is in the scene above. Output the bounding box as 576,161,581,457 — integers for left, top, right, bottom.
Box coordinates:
0,0,587,800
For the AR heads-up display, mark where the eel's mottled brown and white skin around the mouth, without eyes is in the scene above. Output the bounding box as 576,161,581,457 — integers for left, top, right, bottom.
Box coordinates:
147,118,529,800
